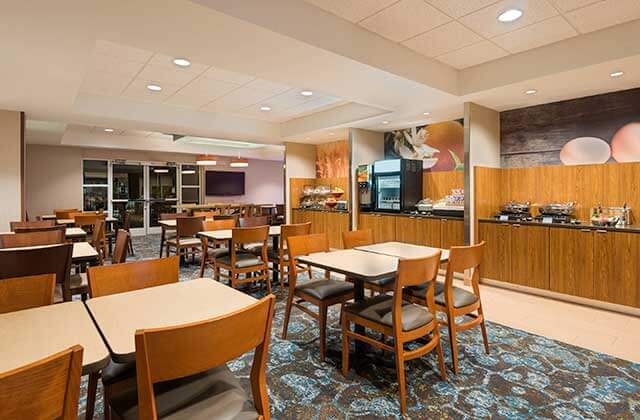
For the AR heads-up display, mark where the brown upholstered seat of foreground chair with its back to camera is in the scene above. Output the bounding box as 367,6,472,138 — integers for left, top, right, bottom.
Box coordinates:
111,365,258,420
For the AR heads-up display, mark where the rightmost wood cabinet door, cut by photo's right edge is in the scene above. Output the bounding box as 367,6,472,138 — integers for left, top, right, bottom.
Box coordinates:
594,230,640,307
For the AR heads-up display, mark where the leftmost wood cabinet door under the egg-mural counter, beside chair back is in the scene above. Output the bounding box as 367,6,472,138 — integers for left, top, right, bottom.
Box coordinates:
478,223,511,282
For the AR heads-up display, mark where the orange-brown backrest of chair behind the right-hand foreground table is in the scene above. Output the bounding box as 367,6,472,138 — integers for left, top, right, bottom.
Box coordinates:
87,256,180,297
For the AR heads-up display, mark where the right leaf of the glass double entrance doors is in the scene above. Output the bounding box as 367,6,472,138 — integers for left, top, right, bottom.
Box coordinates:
147,165,178,233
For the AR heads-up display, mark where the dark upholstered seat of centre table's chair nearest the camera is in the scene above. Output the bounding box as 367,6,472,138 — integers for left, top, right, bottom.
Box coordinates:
344,295,433,331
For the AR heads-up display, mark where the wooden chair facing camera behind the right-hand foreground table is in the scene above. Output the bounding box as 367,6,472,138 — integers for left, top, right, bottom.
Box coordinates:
87,256,180,420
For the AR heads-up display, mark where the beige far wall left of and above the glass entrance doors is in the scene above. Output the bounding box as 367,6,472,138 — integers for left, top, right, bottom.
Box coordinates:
26,144,196,218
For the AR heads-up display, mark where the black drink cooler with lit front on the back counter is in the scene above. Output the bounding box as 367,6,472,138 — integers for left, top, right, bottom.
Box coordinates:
373,159,422,213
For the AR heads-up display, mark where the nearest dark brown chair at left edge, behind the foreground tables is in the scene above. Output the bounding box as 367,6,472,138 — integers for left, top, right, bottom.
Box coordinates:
0,243,73,302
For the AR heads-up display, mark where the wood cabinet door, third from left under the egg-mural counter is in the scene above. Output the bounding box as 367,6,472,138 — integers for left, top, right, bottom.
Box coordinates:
549,228,594,299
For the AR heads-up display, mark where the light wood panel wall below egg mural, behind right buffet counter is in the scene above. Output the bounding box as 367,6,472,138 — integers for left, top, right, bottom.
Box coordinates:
475,162,640,223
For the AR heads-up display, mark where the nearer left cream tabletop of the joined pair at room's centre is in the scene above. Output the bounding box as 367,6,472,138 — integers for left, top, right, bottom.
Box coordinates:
298,249,398,280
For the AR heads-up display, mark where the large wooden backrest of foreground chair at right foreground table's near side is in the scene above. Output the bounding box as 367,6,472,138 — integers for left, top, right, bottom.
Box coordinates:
135,295,275,419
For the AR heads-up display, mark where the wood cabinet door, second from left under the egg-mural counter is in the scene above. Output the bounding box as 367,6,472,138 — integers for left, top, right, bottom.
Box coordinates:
510,225,549,290
